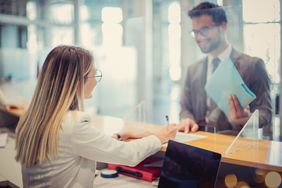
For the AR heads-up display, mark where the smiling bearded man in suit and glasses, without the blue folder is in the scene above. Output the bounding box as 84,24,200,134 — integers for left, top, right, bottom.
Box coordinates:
180,2,272,133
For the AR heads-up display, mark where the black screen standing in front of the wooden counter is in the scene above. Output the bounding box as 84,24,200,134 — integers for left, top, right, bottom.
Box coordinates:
158,140,221,188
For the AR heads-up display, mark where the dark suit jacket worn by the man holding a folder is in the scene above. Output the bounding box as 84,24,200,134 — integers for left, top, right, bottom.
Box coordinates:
180,49,272,131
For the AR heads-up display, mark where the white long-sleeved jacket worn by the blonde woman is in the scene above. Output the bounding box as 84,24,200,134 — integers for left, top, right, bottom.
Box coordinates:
22,111,161,187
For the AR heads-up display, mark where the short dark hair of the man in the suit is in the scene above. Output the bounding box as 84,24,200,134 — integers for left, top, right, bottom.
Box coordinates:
188,2,227,25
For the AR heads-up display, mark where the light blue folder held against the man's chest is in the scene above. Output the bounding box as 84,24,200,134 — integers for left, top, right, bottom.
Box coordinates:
205,59,256,115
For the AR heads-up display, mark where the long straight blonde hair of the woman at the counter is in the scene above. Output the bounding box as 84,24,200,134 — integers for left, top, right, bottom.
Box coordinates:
16,46,93,167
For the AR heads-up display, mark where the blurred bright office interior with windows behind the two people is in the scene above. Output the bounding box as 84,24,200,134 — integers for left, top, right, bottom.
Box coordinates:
0,0,282,140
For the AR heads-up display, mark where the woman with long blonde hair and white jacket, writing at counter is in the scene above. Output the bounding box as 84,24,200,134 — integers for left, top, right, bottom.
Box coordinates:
16,46,176,187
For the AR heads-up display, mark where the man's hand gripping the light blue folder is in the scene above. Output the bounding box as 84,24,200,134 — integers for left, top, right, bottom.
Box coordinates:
228,95,251,125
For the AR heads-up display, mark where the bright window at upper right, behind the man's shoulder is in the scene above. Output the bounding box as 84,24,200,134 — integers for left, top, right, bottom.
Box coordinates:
242,0,281,83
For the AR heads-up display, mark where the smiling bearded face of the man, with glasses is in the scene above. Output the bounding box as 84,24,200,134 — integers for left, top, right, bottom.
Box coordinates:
192,15,226,53
